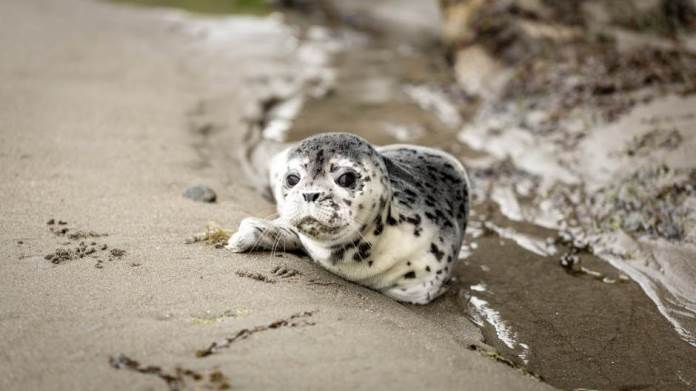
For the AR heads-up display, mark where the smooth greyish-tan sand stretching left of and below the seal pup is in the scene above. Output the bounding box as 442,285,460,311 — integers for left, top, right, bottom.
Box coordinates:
0,0,549,390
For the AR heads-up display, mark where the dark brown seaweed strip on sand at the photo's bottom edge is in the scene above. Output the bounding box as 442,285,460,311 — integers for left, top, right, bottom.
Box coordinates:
109,353,230,391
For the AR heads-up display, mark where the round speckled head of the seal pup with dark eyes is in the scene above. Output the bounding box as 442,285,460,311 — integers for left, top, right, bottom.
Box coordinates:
272,133,391,245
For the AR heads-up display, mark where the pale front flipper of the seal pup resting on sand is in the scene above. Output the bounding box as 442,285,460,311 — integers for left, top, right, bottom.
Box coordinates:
226,217,302,253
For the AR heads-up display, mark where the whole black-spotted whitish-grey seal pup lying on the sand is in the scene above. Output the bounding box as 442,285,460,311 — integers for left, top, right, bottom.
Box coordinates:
227,133,469,304
